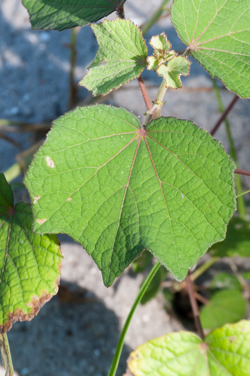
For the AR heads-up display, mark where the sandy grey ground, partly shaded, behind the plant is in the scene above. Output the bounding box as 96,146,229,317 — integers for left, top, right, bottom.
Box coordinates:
0,0,250,376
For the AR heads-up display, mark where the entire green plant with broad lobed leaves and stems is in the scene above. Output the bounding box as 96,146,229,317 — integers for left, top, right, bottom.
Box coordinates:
0,0,250,376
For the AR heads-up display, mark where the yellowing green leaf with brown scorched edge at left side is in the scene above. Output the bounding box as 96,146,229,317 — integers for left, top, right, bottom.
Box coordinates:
0,174,62,332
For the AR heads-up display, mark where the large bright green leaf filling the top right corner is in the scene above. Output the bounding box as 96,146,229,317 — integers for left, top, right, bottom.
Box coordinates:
172,0,250,98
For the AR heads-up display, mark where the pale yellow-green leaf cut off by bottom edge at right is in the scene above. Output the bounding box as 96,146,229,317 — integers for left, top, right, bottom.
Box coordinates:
128,321,250,376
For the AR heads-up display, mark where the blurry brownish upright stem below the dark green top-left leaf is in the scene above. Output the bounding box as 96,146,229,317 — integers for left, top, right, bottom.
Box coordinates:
68,27,77,109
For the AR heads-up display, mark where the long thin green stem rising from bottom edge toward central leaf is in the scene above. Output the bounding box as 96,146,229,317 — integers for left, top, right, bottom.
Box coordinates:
108,261,161,376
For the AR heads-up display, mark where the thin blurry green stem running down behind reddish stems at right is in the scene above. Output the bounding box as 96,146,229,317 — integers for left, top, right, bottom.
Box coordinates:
213,79,246,219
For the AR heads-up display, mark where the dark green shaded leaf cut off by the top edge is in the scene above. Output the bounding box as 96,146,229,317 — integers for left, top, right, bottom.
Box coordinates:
23,0,126,30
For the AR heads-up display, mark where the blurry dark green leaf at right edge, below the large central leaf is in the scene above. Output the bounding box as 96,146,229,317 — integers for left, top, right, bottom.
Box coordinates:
211,217,250,257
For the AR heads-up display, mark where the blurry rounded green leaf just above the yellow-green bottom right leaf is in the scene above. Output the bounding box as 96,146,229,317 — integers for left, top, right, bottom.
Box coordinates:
200,290,247,329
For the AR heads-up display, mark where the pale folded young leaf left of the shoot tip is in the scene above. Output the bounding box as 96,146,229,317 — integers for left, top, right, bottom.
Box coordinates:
80,18,147,95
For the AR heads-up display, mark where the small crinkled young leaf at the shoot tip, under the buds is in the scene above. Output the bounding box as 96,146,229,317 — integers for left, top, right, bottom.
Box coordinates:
157,56,191,89
